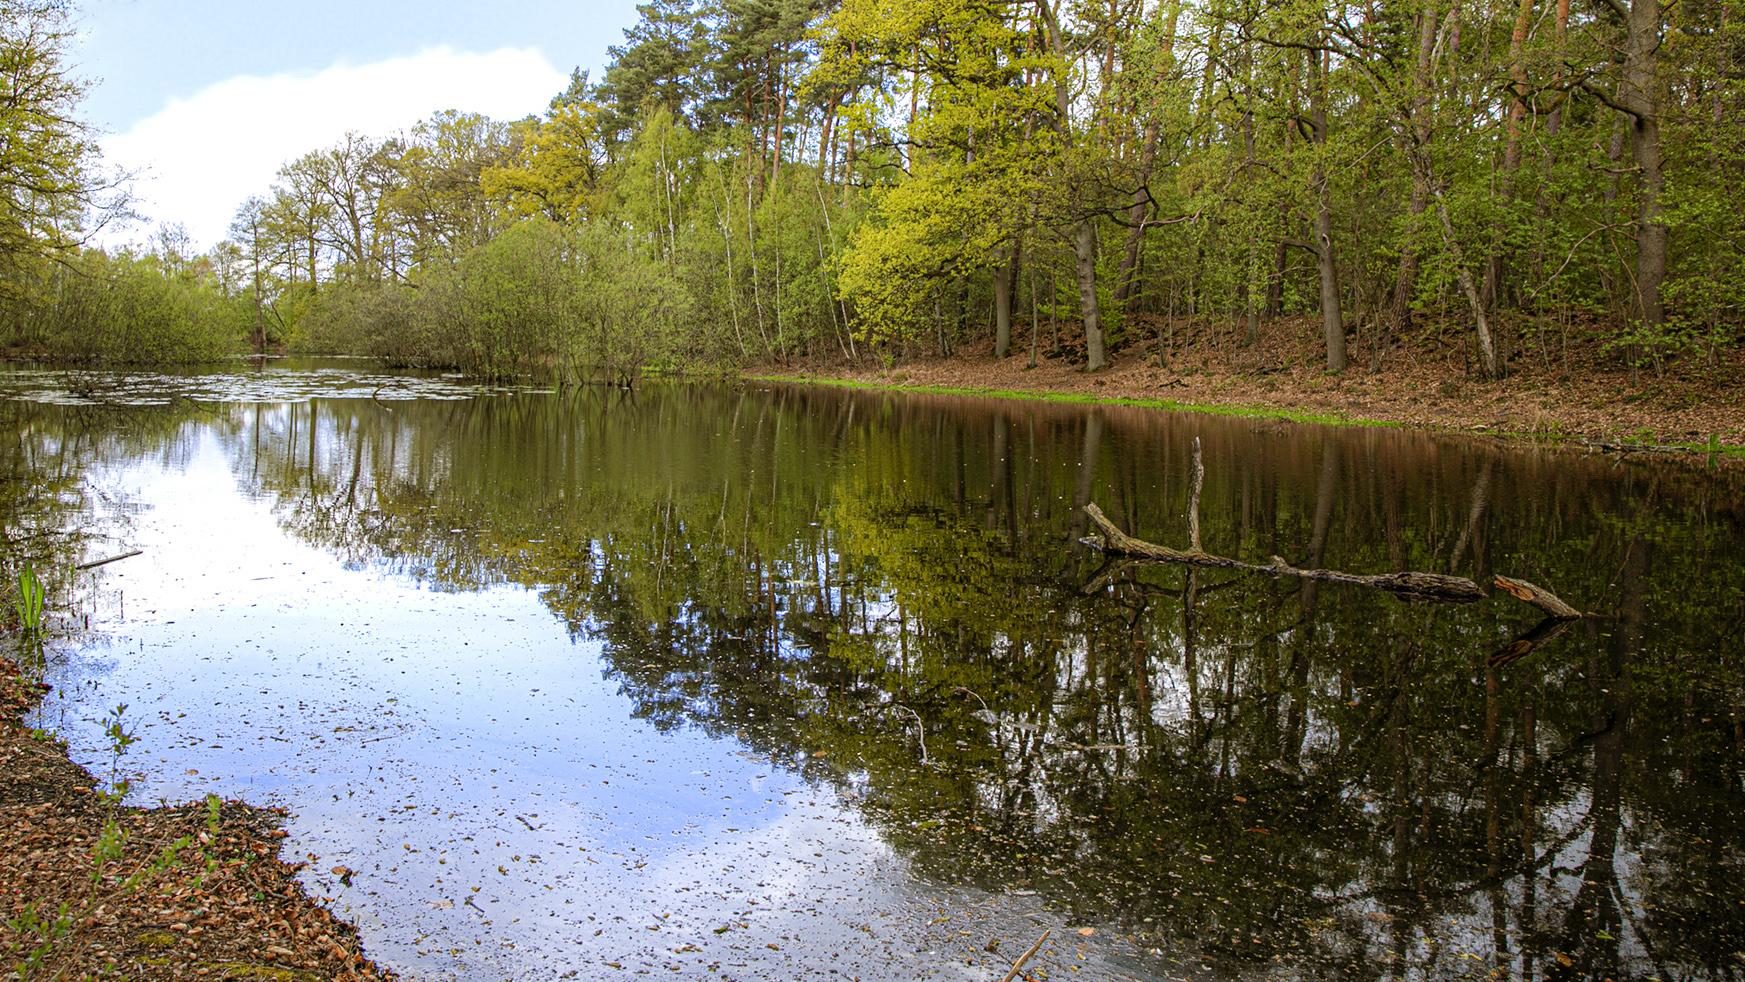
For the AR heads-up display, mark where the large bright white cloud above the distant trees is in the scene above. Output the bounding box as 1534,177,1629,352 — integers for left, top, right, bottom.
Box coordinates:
103,47,569,249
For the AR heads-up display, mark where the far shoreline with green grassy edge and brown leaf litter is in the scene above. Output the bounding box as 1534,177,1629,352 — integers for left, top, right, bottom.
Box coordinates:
738,329,1745,457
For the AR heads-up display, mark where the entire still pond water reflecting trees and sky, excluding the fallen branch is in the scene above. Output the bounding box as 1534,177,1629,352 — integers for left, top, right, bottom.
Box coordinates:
0,363,1745,980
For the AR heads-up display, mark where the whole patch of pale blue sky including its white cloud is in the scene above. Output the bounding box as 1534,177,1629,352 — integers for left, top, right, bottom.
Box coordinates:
73,0,637,246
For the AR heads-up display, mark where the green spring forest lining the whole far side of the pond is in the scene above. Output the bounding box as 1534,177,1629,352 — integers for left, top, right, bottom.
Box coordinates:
0,0,1745,380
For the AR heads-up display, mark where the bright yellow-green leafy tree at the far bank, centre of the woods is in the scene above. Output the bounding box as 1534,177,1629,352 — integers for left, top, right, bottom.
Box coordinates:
808,0,1074,361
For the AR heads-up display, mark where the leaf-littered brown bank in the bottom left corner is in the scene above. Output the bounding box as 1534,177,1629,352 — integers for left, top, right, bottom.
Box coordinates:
0,658,393,982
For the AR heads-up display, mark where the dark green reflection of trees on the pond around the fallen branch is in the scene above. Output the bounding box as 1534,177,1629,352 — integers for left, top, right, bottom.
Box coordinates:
207,389,1745,979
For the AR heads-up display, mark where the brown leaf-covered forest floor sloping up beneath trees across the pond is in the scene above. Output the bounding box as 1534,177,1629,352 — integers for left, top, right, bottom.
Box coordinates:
743,319,1745,448
